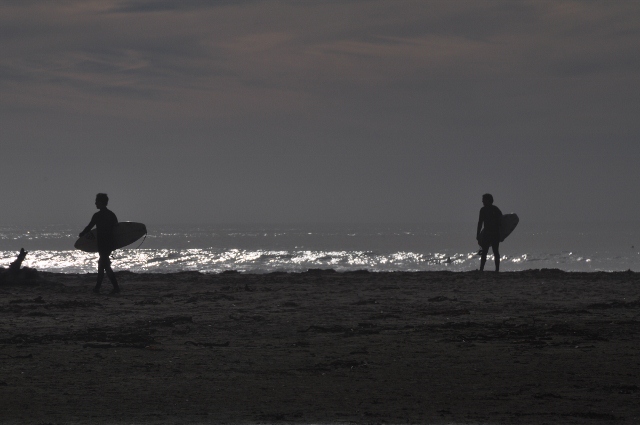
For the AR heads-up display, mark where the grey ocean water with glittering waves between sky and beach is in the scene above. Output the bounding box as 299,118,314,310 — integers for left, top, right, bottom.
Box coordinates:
0,217,640,273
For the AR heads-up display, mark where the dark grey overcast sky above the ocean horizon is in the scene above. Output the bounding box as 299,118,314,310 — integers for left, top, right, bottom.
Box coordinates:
0,0,640,225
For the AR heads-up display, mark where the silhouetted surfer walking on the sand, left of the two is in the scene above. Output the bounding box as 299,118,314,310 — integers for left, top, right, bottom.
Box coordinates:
80,193,120,294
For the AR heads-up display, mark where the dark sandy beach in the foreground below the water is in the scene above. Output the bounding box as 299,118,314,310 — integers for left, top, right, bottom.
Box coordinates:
0,270,640,424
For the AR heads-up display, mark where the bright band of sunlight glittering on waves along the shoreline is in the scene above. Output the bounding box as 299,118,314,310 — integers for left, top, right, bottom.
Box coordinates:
0,249,628,273
